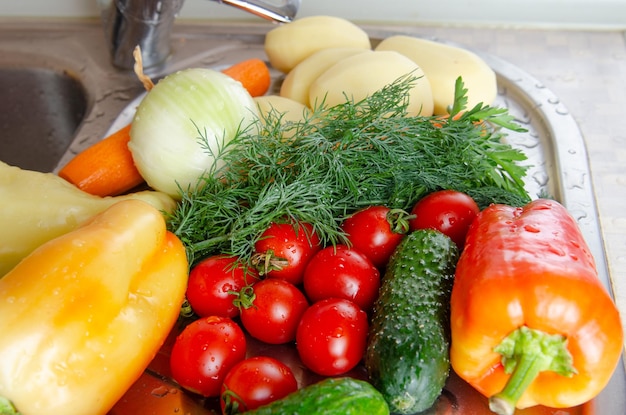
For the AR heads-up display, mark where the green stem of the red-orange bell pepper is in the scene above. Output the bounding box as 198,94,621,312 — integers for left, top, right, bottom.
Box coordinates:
489,326,576,415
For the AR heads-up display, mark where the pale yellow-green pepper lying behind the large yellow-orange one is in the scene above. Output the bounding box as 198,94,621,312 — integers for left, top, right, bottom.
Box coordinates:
0,162,176,278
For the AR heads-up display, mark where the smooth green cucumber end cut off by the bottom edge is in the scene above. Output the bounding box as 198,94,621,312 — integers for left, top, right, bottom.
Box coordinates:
244,377,389,415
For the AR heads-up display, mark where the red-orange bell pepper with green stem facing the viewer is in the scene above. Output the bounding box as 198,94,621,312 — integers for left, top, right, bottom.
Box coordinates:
450,199,624,414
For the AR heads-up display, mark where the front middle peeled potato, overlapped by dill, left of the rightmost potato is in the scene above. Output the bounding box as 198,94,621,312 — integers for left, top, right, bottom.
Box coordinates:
309,51,433,116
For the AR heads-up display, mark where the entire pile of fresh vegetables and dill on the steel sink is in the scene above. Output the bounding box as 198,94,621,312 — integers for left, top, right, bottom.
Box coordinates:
0,16,623,415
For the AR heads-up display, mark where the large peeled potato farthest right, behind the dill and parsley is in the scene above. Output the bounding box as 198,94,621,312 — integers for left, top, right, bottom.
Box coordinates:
376,35,498,115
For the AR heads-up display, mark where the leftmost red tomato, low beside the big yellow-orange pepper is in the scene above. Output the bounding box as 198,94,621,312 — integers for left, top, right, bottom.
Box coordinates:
170,316,246,397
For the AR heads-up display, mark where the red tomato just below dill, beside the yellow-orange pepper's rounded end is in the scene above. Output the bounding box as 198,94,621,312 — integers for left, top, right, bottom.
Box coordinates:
186,256,258,318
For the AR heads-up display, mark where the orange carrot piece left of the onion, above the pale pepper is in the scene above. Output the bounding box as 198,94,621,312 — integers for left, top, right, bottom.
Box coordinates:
58,124,144,196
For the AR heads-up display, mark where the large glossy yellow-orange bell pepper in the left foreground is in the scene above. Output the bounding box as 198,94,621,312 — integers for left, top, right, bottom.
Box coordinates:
0,200,188,415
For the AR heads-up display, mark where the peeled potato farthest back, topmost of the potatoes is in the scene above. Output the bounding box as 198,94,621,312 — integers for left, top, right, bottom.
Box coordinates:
264,16,372,73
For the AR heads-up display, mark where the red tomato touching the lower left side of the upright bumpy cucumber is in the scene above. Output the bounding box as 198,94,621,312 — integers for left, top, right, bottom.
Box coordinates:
296,298,368,376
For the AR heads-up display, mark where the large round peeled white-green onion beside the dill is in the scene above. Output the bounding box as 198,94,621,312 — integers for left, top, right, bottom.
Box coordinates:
128,68,258,199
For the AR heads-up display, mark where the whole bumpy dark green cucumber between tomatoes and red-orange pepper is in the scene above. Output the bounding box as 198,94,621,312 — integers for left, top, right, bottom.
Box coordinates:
365,230,459,414
